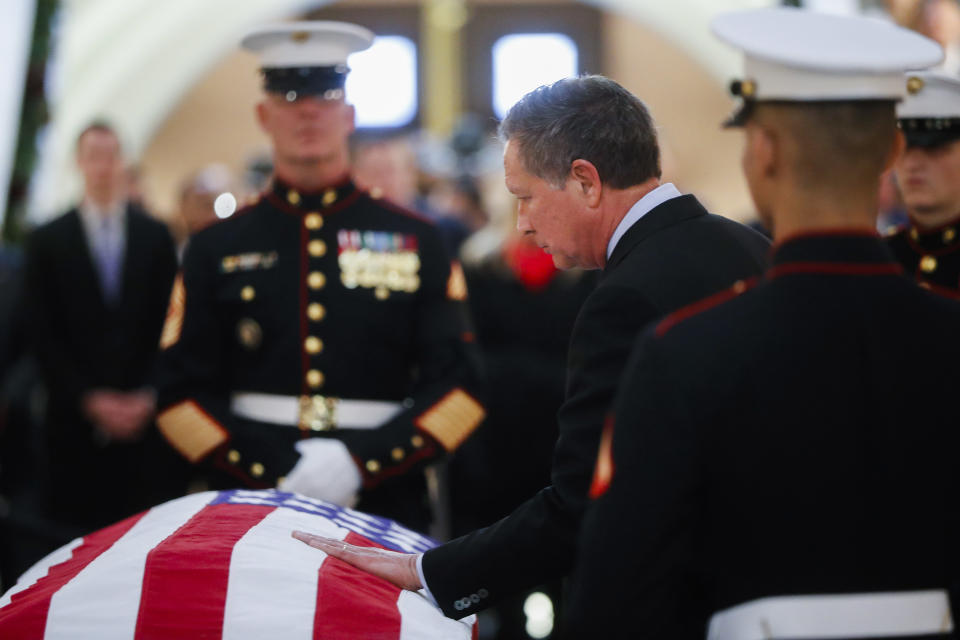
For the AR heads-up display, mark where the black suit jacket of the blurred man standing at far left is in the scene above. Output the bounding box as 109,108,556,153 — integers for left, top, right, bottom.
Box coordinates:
25,206,177,523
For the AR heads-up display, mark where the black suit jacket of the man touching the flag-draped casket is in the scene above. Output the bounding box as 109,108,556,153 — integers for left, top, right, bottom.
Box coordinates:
423,195,769,618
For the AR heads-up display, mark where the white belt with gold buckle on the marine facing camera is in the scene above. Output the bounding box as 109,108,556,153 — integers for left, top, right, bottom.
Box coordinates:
230,393,403,431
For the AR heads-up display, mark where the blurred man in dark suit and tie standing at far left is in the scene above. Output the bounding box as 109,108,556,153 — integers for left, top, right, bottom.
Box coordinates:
25,123,182,539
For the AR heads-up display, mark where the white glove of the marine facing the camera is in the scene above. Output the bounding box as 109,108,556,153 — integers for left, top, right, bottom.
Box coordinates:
278,438,361,507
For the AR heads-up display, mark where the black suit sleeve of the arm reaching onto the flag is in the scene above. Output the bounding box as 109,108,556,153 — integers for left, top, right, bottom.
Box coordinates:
423,285,659,618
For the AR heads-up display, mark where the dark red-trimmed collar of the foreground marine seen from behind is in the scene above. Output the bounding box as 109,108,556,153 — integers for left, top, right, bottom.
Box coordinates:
768,228,903,277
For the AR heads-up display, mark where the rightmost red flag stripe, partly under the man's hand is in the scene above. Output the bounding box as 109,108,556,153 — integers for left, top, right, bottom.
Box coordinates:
313,532,400,640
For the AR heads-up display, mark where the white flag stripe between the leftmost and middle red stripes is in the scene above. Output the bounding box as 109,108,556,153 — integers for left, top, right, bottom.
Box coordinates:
43,491,217,640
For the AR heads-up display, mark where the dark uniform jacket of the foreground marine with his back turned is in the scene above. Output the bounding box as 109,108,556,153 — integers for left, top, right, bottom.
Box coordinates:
568,235,960,640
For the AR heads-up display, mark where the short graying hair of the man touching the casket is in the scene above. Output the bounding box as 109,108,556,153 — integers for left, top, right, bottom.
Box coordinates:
499,75,660,189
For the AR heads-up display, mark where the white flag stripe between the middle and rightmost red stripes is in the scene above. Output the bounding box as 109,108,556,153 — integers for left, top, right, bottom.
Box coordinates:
222,507,348,640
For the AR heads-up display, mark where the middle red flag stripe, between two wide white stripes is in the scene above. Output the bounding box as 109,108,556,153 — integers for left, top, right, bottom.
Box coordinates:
135,504,275,640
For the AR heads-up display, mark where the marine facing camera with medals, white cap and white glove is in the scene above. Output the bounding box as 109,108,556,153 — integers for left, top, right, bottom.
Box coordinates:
158,23,484,530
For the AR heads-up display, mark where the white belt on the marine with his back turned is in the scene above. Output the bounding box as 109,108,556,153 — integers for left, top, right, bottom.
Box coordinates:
707,590,953,640
